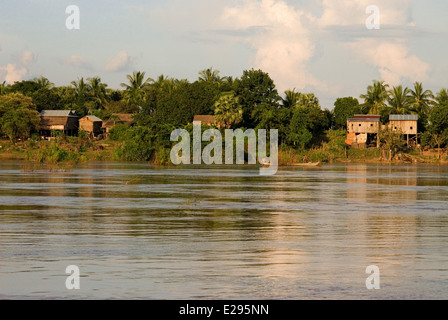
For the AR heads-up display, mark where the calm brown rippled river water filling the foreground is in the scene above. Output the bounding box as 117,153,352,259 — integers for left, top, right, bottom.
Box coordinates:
0,162,448,299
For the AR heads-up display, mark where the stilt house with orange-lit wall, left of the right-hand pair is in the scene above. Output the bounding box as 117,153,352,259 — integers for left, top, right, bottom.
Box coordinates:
345,115,381,148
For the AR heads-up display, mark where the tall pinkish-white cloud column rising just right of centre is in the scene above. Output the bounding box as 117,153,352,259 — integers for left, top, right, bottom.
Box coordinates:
222,0,321,92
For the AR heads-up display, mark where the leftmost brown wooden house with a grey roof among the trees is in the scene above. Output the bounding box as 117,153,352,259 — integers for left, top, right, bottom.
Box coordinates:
40,110,79,136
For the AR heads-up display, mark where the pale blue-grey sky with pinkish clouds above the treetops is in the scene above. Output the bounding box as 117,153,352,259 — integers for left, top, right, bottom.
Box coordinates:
0,0,448,109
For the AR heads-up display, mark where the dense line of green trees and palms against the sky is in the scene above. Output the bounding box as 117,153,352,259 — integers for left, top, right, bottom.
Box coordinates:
0,68,448,159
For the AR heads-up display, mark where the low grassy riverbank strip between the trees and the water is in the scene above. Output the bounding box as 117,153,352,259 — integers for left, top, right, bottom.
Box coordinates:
0,137,448,166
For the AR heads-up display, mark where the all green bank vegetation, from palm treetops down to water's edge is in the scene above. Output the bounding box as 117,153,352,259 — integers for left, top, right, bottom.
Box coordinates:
0,68,448,165
